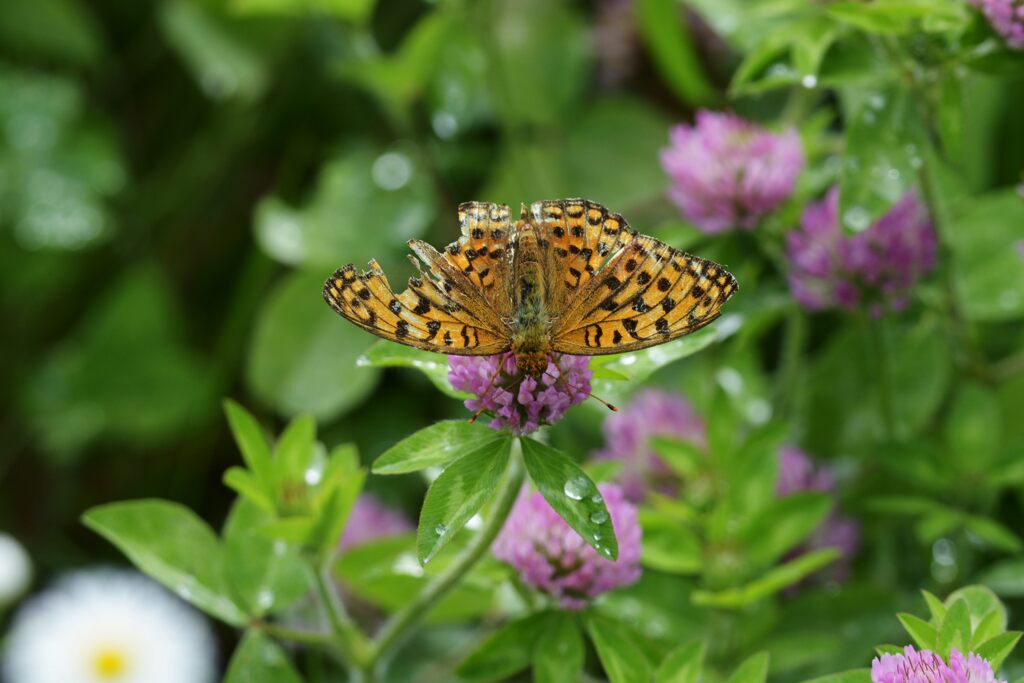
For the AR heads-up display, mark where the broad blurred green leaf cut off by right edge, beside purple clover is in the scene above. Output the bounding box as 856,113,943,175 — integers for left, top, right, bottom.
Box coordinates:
943,189,1024,322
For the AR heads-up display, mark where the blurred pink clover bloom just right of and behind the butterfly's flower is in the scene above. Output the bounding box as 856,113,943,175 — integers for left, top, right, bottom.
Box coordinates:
595,389,708,503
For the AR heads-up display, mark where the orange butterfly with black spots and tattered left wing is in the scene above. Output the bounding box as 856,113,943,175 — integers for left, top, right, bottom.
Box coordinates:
324,199,737,377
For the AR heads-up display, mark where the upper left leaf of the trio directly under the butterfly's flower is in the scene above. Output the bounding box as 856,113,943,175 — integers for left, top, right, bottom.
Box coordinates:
373,420,509,474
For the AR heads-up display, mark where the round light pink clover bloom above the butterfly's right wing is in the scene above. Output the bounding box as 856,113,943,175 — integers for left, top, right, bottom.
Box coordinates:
662,111,804,233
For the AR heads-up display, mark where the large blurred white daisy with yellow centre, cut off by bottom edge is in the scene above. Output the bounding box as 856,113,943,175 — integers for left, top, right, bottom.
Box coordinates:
2,570,216,683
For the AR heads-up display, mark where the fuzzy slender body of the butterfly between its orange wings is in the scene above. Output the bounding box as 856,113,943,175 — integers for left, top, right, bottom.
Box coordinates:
512,222,551,377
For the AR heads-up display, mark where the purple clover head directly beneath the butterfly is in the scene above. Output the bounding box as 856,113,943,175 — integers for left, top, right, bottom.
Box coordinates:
449,352,594,435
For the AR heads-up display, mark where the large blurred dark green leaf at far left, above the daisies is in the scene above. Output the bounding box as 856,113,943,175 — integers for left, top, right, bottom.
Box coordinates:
24,266,217,459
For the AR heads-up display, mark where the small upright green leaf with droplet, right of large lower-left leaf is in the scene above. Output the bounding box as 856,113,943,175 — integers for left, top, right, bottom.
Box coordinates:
224,499,309,617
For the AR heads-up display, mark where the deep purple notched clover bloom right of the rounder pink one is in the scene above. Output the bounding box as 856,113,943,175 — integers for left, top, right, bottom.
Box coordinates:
786,187,937,315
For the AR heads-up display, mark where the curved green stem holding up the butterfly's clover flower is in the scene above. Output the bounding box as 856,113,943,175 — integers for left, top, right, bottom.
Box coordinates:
362,438,525,683
